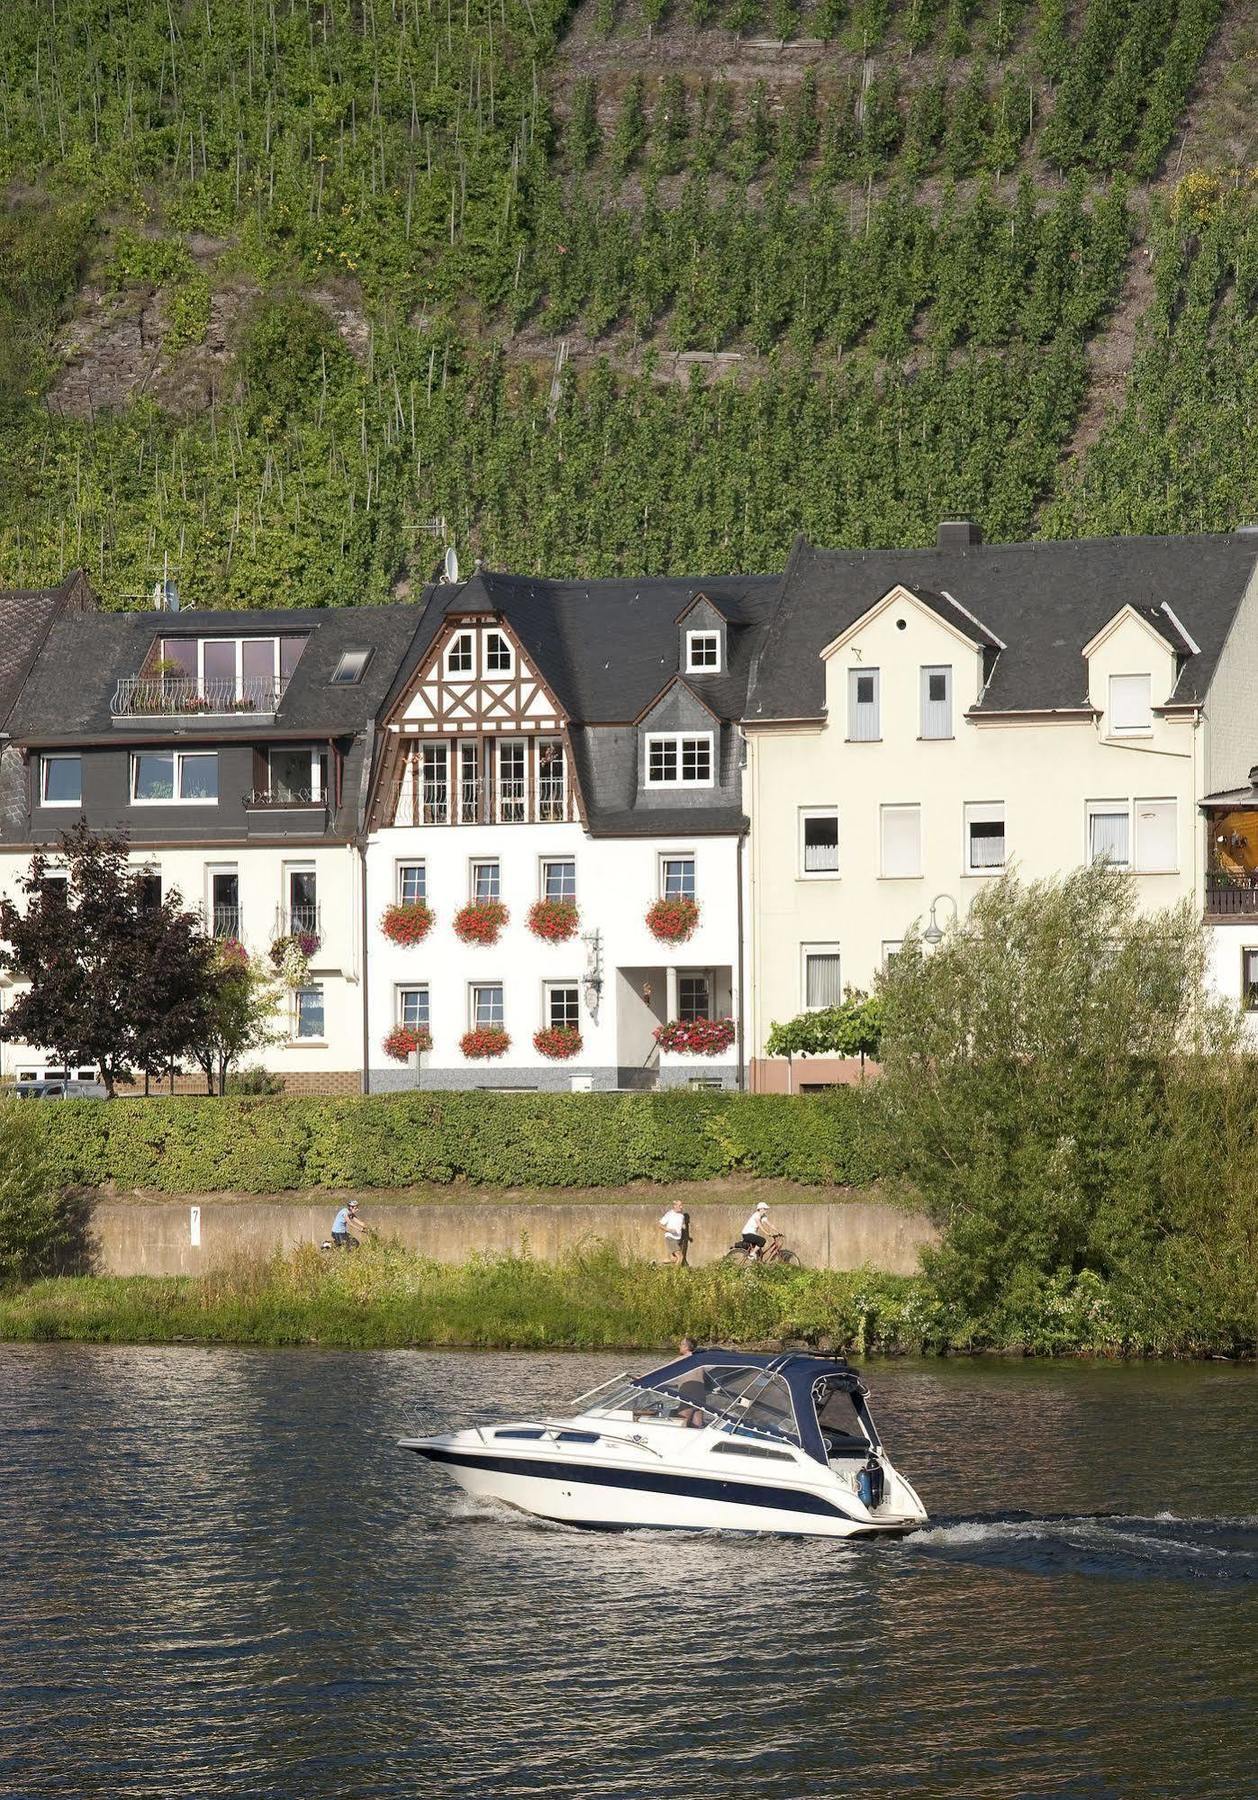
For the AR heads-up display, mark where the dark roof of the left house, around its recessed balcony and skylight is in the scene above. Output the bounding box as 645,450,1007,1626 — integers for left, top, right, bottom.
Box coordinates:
7,605,419,743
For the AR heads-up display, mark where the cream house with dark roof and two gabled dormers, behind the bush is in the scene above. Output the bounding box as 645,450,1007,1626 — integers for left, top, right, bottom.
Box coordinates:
745,522,1258,1089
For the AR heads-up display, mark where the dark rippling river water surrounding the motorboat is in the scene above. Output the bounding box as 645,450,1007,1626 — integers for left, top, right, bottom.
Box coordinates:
0,1345,1258,1800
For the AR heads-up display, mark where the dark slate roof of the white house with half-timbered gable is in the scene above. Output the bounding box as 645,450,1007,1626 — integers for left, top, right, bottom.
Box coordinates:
389,571,781,724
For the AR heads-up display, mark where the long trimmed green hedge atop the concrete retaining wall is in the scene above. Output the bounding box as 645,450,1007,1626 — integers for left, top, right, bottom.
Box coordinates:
38,1089,875,1193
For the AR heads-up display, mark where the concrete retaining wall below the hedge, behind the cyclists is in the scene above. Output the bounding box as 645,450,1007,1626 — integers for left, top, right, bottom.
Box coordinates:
94,1190,936,1274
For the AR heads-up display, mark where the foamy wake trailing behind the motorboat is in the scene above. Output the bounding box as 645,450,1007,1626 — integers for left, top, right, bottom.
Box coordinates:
907,1512,1258,1584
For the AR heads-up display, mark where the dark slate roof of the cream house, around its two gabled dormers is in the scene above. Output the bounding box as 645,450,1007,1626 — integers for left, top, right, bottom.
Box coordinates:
747,533,1258,722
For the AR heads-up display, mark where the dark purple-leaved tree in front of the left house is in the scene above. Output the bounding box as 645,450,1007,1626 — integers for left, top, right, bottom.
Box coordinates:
0,824,214,1094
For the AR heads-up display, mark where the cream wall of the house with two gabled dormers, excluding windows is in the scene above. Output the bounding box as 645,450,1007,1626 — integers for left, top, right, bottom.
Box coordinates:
745,594,1204,1058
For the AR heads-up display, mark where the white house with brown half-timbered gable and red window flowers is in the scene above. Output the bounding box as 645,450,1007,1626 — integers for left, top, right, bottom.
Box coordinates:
367,574,776,1089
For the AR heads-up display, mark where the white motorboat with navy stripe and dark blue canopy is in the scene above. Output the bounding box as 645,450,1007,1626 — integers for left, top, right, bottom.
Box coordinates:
400,1350,927,1537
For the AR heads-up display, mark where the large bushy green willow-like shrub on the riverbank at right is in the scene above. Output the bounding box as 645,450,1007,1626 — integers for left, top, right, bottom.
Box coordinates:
871,866,1258,1343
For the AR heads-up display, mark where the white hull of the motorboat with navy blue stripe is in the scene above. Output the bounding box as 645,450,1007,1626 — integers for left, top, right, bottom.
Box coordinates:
403,1440,923,1537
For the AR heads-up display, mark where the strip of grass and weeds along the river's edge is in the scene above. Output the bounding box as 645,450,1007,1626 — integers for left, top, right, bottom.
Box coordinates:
0,1244,1253,1355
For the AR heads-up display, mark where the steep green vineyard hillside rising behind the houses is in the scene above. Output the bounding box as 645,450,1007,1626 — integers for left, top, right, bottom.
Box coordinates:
0,0,1258,607
